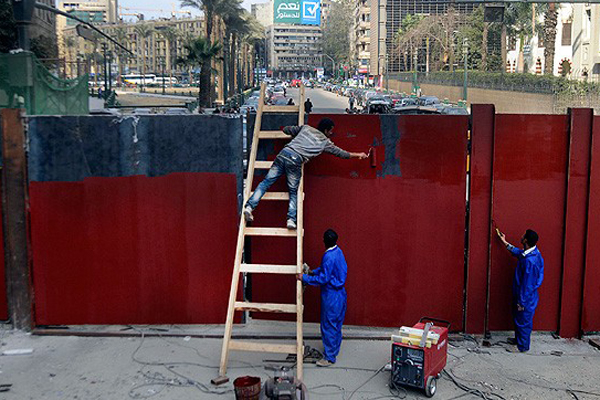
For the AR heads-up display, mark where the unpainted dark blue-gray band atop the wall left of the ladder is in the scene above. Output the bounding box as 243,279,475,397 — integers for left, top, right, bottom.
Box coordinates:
28,115,243,193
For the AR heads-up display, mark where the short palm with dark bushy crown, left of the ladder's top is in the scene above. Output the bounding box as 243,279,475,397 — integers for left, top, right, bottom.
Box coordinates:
179,36,223,107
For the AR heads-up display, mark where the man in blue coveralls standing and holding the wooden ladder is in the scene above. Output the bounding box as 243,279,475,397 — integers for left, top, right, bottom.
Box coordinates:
297,229,348,367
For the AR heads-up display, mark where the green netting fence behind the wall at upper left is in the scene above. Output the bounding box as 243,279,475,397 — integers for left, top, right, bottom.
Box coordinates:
0,52,89,115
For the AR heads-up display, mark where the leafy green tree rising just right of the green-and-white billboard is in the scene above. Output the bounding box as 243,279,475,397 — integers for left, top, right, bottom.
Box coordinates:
323,0,354,73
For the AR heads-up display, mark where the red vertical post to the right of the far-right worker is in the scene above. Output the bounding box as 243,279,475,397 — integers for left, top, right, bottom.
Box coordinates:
558,109,594,337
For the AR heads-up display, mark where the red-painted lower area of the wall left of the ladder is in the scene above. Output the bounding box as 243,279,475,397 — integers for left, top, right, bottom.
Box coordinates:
30,173,238,325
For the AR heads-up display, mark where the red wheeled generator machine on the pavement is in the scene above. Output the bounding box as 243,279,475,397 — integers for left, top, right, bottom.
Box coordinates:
392,317,450,397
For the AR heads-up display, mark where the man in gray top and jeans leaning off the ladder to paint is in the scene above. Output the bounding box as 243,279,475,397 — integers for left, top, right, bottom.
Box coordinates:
244,118,367,229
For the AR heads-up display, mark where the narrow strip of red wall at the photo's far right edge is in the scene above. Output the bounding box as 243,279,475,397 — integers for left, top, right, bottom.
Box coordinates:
581,117,600,332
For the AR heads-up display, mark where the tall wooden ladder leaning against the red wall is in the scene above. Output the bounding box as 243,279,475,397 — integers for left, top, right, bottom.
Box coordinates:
218,83,304,384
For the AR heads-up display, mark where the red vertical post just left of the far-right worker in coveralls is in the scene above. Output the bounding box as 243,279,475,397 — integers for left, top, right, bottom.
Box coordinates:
465,104,495,334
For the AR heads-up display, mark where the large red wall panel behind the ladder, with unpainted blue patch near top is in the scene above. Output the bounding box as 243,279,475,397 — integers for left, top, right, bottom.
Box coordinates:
252,115,468,330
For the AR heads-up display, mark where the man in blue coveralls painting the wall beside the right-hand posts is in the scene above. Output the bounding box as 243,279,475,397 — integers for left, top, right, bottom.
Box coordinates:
496,229,544,352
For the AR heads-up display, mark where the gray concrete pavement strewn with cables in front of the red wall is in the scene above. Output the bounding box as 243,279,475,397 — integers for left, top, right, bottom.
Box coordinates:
0,321,600,400
